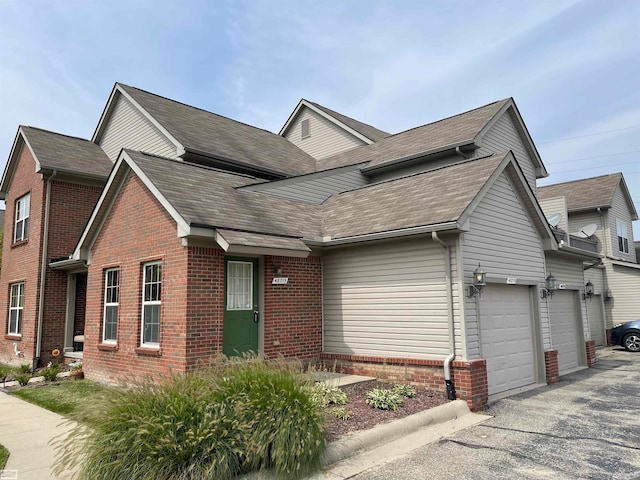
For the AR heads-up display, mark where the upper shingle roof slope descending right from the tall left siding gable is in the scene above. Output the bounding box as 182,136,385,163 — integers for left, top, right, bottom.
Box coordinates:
118,83,315,176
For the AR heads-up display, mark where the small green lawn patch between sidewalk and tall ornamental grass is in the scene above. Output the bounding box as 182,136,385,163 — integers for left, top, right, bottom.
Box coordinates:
12,380,111,425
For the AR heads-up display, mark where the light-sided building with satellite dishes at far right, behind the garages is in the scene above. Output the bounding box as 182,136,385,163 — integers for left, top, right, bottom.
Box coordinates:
538,173,640,346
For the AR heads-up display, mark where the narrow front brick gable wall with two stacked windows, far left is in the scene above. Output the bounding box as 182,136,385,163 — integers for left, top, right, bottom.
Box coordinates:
0,147,44,365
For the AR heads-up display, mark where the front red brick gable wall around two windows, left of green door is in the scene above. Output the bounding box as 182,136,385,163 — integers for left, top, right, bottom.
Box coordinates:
83,173,188,383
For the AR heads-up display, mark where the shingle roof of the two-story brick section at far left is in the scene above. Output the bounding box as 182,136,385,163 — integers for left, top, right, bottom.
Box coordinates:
20,126,113,179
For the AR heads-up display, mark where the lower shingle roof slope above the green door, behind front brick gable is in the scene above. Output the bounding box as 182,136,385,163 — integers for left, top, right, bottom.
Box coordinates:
127,150,321,238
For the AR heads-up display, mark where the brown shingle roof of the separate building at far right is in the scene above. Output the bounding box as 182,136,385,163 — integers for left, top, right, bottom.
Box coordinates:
537,173,622,211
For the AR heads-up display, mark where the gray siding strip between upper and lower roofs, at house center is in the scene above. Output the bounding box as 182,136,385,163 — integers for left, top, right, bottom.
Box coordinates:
240,167,369,204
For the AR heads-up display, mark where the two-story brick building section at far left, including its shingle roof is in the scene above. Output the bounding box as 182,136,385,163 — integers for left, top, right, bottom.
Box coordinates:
0,126,111,364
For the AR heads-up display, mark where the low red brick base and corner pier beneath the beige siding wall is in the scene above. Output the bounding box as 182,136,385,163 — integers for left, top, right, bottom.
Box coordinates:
321,353,488,412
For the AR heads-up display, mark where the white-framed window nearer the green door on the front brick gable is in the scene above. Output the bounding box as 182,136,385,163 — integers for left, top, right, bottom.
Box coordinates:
141,262,162,347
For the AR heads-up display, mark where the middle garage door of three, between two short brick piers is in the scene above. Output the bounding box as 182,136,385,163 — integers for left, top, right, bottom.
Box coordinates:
549,290,583,375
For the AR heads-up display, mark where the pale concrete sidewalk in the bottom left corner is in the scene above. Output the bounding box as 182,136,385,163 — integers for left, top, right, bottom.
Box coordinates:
0,392,75,480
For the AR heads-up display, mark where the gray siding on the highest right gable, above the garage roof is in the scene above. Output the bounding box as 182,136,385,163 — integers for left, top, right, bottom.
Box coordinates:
477,111,536,193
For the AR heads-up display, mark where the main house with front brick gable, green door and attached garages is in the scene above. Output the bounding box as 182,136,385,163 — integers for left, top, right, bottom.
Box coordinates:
0,84,616,409
